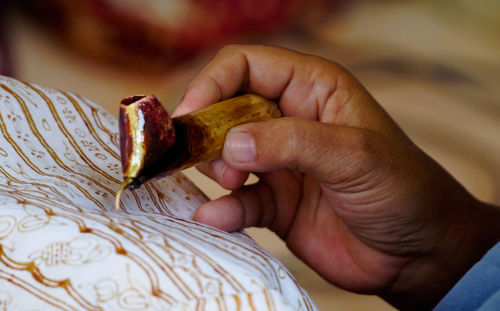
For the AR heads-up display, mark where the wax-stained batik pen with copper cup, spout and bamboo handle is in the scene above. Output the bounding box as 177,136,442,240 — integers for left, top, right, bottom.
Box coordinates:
115,94,281,210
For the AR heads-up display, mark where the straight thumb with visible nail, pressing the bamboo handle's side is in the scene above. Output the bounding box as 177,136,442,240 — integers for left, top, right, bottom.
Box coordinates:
222,117,379,182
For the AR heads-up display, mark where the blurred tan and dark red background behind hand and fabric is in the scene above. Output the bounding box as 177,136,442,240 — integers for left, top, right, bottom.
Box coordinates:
0,0,500,310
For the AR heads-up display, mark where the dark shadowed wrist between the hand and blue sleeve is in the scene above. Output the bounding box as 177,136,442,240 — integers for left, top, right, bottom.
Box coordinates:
382,195,500,310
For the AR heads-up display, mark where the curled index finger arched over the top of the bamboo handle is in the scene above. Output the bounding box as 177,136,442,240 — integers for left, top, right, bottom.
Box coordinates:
174,45,401,140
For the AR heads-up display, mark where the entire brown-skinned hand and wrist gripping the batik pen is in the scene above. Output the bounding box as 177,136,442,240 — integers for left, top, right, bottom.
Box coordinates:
174,45,500,310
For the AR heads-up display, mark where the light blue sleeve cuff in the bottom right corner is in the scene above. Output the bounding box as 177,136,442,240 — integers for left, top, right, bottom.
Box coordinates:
434,243,500,311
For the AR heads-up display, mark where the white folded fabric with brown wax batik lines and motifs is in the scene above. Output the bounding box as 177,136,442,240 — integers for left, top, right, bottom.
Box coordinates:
0,76,316,310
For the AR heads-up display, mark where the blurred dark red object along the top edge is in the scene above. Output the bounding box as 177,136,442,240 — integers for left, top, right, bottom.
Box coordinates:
18,0,332,66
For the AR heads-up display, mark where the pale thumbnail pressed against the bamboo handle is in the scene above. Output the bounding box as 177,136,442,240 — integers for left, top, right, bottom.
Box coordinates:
224,129,255,162
